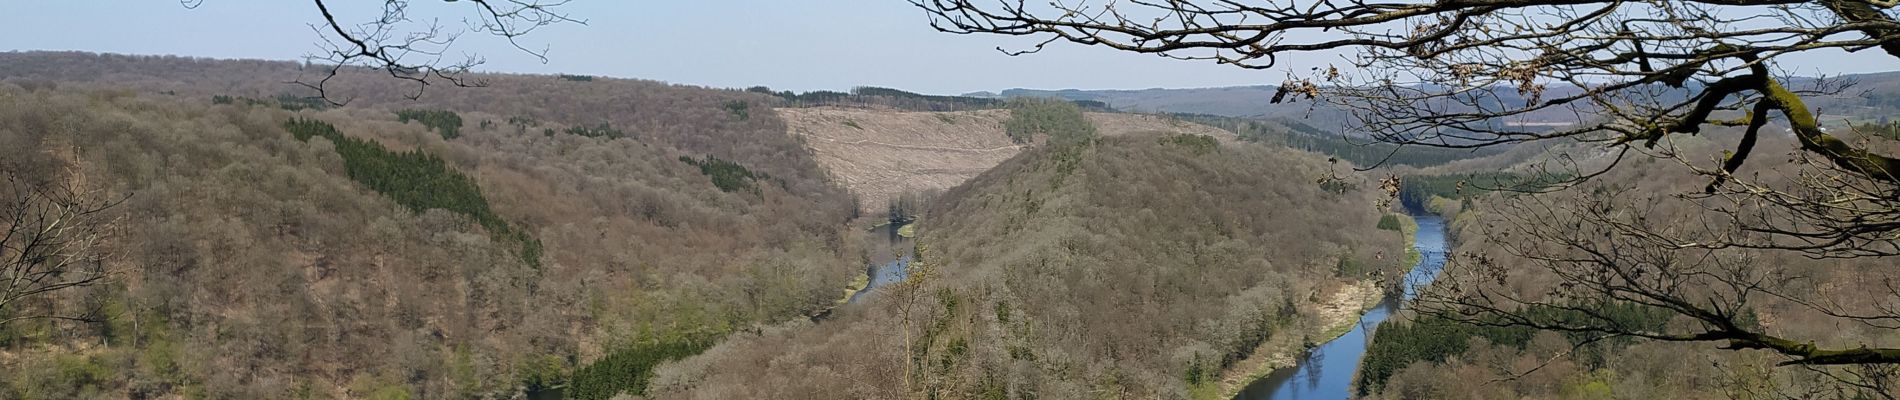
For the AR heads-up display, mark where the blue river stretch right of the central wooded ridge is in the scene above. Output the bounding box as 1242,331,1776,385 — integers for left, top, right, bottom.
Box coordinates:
1235,214,1446,400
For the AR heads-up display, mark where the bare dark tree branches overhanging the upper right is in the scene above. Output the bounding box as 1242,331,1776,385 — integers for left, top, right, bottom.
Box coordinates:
912,0,1900,258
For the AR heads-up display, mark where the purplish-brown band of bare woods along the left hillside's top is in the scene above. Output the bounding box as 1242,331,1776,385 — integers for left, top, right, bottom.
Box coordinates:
0,51,849,211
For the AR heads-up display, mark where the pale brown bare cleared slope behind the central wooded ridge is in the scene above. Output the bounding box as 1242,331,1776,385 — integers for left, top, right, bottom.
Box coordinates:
777,106,1237,212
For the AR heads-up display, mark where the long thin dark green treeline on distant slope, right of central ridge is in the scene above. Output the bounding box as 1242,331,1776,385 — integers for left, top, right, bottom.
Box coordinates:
1170,114,1505,167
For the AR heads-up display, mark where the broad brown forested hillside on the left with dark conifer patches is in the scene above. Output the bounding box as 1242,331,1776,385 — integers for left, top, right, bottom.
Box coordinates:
0,53,861,398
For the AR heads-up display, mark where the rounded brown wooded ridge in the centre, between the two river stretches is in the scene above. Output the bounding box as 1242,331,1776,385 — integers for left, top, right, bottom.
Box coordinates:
648,135,1404,398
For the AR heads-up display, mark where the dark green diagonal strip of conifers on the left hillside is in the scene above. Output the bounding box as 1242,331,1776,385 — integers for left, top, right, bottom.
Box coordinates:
283,112,542,267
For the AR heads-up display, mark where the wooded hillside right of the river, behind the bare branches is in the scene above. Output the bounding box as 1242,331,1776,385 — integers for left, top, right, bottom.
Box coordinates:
1357,129,1900,398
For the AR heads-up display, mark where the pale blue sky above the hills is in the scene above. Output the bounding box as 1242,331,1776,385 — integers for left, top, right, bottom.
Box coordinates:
0,0,1900,93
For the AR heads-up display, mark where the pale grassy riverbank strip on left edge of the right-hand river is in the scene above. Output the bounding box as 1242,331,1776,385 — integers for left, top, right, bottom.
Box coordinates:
1191,279,1385,398
